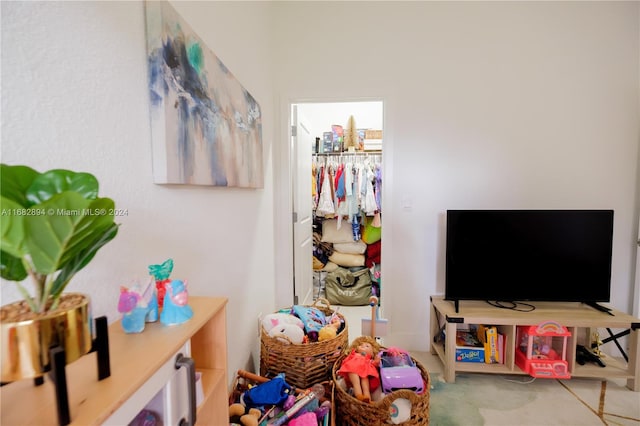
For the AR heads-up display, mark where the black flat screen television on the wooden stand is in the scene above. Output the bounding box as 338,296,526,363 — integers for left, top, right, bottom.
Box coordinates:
445,210,613,311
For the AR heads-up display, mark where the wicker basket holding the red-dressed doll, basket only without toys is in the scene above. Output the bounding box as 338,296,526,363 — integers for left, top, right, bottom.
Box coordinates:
332,336,430,426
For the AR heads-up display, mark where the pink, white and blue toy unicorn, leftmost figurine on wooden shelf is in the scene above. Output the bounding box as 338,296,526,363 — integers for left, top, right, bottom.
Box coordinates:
118,280,158,333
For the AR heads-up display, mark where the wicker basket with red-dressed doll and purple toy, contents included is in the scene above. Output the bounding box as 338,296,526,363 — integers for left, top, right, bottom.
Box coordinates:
333,336,430,426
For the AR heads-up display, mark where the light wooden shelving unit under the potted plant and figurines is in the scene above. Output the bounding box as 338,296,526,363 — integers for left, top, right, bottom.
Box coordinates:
0,297,228,426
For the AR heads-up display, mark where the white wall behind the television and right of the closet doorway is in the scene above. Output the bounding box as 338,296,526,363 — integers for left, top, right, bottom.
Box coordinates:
274,2,640,350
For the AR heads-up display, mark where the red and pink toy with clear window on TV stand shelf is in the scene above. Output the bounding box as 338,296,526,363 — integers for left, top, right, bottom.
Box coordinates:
515,321,571,379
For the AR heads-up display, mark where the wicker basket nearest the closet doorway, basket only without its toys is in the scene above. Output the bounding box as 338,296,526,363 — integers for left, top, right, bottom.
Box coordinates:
260,298,349,389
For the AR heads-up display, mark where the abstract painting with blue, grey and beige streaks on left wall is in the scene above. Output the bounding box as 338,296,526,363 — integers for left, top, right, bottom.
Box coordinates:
146,1,264,188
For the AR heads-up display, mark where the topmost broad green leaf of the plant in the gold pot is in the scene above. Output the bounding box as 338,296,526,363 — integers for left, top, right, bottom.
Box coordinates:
26,169,98,204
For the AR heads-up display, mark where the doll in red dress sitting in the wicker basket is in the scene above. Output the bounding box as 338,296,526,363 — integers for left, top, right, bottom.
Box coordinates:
338,342,380,402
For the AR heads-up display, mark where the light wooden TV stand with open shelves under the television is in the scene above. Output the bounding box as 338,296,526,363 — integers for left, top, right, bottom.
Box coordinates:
431,296,640,392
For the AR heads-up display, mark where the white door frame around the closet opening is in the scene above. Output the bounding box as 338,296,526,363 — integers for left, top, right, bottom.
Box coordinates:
273,96,390,306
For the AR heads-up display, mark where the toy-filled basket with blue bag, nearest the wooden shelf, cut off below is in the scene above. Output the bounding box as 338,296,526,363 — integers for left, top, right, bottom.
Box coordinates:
229,370,336,426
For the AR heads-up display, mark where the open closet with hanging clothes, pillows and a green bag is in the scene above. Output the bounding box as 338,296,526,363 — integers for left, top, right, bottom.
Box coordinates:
297,102,384,312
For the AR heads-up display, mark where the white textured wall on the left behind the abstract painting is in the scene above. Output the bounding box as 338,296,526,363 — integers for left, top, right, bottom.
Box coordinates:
1,2,275,379
